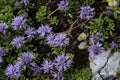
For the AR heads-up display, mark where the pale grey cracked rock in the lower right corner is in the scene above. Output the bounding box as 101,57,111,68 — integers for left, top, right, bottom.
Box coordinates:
89,49,120,80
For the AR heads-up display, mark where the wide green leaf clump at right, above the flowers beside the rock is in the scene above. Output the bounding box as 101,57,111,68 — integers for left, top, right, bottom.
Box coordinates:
86,15,115,39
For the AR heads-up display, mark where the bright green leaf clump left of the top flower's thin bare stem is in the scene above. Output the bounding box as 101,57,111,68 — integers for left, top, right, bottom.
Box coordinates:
36,6,48,22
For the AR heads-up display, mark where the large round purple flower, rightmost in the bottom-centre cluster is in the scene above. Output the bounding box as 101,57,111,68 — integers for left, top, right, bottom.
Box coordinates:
54,54,71,72
